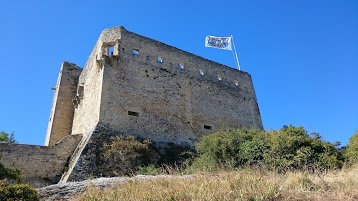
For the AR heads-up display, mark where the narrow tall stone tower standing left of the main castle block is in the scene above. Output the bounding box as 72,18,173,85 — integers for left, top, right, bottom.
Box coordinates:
45,62,82,146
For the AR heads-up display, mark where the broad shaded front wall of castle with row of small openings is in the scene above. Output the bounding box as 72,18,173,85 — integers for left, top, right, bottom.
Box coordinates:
97,27,263,143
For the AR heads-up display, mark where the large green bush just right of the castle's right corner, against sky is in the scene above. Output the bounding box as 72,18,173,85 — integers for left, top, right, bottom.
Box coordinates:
263,125,343,171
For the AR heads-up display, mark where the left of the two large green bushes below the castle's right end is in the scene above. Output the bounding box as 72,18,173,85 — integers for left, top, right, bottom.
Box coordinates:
192,129,267,170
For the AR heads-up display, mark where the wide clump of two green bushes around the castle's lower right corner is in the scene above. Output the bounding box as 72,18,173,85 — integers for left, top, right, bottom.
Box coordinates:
191,125,344,172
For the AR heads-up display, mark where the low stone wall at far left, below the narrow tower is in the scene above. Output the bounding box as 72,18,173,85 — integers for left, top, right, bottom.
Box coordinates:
0,135,82,187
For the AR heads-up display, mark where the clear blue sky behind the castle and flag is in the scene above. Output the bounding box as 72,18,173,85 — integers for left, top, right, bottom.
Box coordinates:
0,0,358,144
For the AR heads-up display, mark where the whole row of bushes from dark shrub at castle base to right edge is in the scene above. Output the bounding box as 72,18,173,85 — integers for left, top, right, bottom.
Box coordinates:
98,125,358,176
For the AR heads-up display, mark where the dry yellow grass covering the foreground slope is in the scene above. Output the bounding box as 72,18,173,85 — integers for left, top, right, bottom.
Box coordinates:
79,167,358,201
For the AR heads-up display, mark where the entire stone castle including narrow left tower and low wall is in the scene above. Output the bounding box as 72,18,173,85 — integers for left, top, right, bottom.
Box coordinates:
0,27,263,186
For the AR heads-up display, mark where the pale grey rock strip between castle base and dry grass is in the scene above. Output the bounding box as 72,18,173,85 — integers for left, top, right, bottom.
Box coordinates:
37,175,192,201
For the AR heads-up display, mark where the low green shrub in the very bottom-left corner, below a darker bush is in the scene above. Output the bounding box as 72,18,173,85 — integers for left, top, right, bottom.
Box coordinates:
0,181,39,201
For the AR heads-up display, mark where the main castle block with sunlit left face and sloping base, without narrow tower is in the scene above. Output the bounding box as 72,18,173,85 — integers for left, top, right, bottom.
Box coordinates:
40,27,263,182
